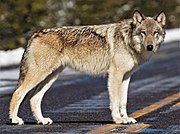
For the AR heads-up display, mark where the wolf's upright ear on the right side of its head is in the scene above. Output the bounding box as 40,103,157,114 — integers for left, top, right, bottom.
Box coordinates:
154,11,166,27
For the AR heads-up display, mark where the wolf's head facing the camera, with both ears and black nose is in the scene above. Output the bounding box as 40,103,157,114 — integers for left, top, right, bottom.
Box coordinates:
132,10,166,52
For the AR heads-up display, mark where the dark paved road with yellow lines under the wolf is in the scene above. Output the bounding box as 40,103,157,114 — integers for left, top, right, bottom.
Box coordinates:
0,42,180,134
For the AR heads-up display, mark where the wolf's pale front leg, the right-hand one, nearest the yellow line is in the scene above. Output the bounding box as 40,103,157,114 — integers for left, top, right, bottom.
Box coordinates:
119,77,137,123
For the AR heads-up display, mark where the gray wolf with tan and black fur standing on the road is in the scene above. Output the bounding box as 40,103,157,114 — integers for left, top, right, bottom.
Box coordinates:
9,10,166,125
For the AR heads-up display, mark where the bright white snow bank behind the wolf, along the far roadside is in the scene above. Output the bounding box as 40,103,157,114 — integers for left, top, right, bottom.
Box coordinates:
0,28,180,67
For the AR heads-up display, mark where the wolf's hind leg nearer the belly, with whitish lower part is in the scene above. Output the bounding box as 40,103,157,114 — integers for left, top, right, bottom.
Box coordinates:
30,68,63,125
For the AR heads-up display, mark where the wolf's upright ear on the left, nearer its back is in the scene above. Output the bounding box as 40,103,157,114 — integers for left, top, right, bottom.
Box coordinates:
133,10,145,25
